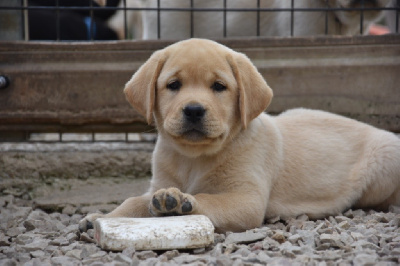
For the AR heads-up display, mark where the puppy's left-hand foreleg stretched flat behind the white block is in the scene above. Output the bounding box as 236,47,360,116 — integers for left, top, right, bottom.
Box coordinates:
79,194,151,232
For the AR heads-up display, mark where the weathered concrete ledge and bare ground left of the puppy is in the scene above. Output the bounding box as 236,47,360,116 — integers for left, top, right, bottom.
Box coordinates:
0,143,154,214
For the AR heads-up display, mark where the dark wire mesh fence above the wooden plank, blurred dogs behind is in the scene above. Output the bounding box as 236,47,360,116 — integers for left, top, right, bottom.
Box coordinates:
0,0,400,41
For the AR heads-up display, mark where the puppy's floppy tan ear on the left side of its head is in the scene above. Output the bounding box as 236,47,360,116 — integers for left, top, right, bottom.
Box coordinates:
124,50,166,124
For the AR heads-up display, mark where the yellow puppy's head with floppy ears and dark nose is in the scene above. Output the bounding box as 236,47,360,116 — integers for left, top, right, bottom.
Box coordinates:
124,39,272,156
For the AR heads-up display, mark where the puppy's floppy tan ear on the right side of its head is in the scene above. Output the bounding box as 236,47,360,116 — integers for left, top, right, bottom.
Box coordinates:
228,52,273,128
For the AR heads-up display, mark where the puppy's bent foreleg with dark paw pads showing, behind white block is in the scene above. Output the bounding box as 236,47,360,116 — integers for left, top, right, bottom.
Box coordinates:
149,188,266,232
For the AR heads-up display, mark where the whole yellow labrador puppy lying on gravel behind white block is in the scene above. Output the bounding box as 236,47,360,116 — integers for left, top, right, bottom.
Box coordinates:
80,39,400,232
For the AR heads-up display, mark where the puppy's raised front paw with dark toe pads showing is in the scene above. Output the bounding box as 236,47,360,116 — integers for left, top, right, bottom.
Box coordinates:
149,188,196,216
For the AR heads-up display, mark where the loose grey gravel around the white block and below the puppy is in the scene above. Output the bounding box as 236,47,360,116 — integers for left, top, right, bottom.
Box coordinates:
0,195,400,265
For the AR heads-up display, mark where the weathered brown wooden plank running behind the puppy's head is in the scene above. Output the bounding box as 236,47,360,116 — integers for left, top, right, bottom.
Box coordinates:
0,35,400,136
